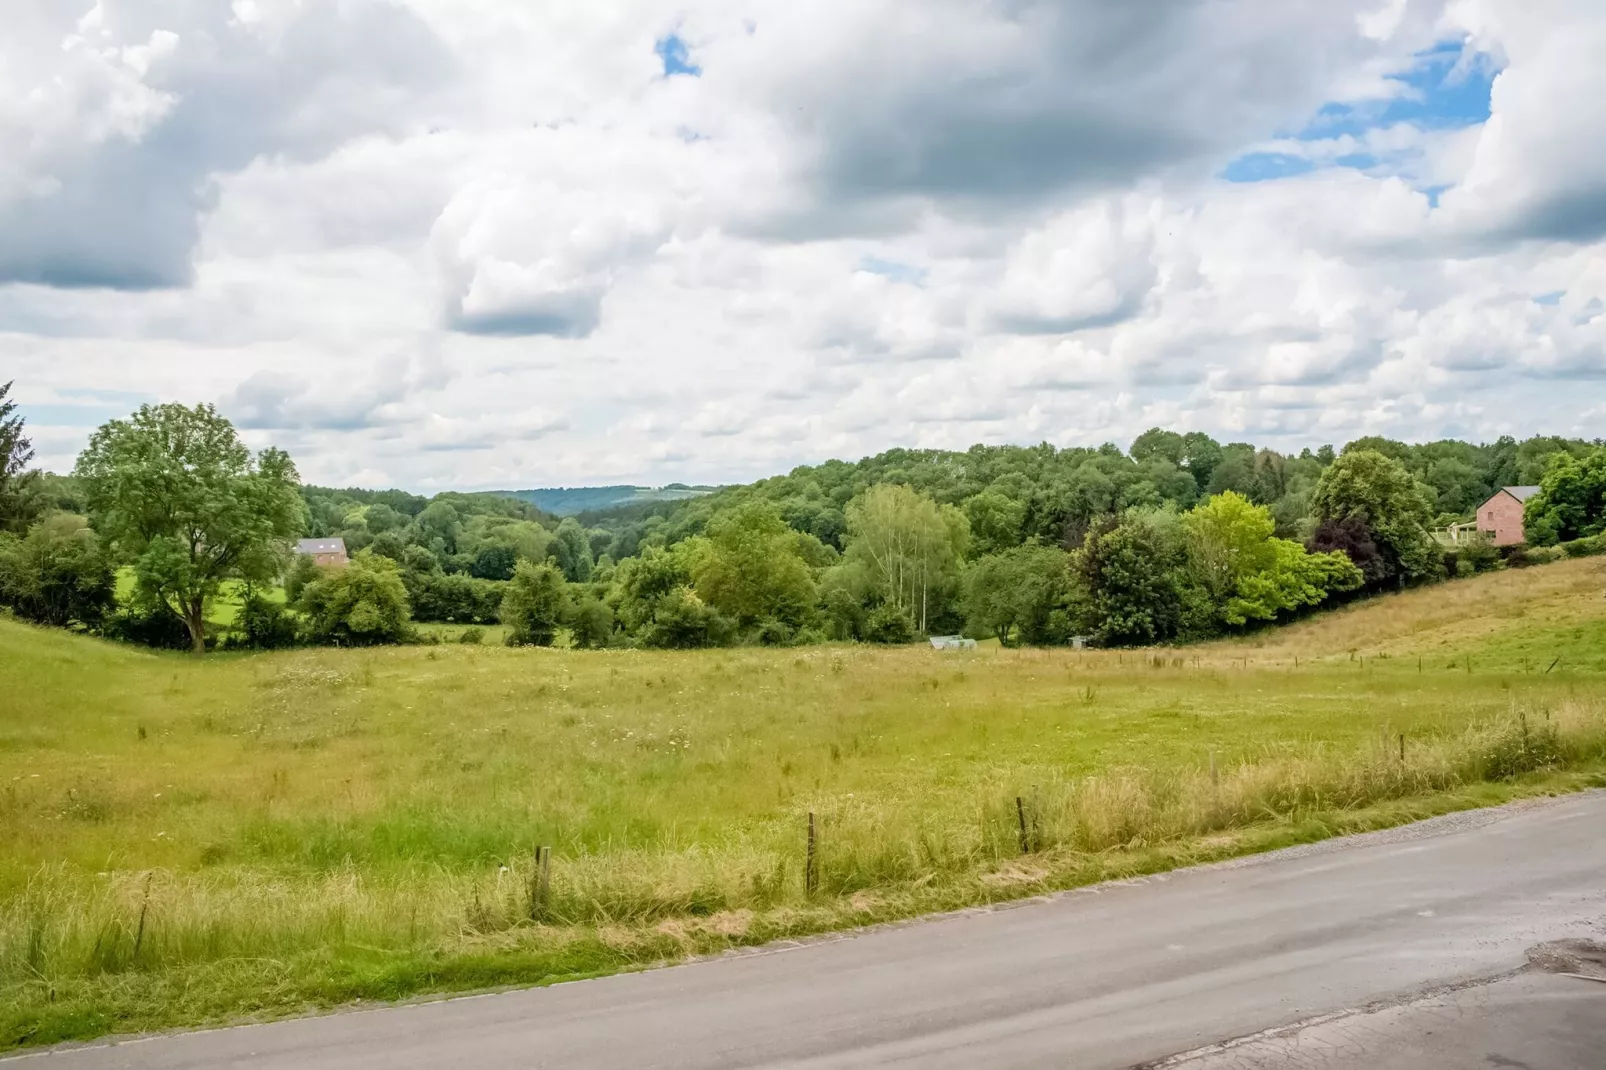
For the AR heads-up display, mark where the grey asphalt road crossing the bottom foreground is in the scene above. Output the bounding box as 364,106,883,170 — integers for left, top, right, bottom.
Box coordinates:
19,792,1606,1070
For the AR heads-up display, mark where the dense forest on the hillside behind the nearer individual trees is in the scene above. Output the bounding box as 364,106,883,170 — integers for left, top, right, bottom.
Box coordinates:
578,429,1600,559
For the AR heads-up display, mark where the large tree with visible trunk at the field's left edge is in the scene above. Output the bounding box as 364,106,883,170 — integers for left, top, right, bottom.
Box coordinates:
75,403,305,654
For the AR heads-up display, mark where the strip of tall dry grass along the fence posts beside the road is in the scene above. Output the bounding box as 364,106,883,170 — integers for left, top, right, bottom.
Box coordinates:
0,700,1606,1001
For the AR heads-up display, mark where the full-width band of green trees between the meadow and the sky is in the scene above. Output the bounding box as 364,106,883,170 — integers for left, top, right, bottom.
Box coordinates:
0,387,1606,652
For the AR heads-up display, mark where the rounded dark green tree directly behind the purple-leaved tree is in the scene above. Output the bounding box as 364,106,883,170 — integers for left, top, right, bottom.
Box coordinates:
1310,447,1441,583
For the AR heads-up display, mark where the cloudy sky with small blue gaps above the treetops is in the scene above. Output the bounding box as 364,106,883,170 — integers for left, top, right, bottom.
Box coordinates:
0,0,1606,492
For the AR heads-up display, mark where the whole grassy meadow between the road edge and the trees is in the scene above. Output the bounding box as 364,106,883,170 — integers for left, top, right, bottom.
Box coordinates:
0,561,1606,1048
